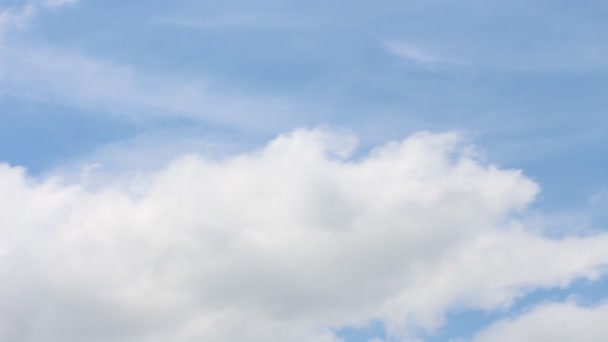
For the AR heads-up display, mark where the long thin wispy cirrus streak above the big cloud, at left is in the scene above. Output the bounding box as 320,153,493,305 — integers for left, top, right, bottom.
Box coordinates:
0,47,297,129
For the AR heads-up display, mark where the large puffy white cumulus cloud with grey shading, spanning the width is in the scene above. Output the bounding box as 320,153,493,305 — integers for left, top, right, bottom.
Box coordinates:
0,130,608,341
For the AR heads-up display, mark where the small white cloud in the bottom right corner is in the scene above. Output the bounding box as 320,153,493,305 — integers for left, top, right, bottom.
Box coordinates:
474,302,608,342
